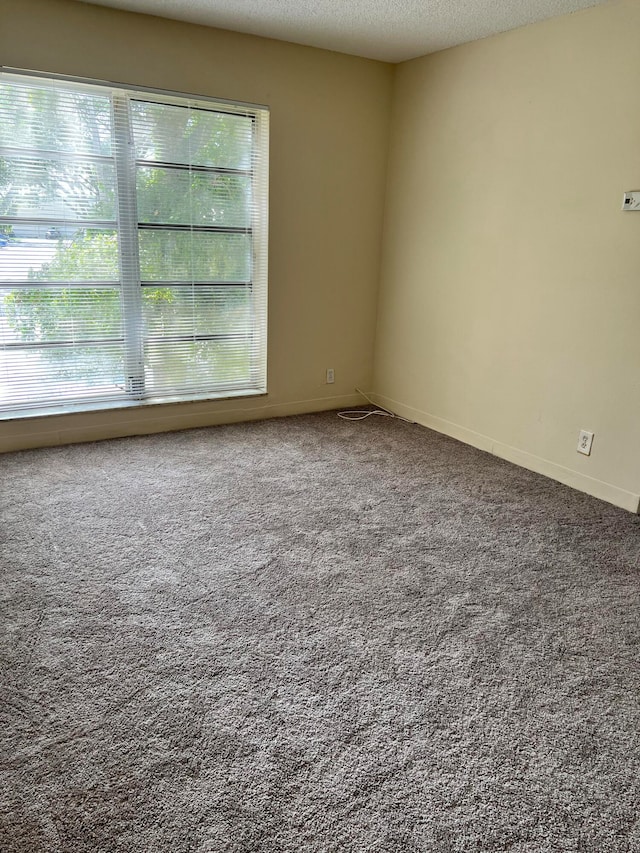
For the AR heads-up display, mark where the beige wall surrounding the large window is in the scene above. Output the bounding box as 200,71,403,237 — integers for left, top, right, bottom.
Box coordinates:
0,0,393,450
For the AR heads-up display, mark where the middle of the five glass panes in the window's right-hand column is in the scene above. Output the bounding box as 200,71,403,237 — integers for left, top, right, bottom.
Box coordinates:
138,231,251,281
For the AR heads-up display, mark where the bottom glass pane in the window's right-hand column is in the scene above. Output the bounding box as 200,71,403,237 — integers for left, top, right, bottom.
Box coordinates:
145,339,251,394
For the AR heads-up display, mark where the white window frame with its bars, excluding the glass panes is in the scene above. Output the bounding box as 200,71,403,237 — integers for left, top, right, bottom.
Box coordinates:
0,66,269,420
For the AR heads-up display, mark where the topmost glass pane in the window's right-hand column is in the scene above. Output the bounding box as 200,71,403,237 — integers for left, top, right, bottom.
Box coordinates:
131,101,253,169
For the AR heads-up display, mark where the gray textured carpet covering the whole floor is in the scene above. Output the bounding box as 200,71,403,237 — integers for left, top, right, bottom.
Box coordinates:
0,413,640,853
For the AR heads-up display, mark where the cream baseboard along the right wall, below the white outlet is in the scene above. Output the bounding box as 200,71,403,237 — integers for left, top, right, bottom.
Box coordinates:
368,392,640,513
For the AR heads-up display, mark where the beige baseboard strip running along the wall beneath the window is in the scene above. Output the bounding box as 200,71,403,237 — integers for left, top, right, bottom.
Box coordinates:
0,394,362,453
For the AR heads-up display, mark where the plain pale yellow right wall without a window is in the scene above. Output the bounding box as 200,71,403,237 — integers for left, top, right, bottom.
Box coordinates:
372,0,640,510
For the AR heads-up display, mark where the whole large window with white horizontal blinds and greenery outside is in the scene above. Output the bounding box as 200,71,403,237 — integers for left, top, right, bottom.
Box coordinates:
0,73,269,417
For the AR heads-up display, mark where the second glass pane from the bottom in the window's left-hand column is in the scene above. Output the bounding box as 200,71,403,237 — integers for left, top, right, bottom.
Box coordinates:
0,287,122,345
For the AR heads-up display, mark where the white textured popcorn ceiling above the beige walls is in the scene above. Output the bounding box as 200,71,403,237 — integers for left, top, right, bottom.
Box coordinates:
77,0,603,62
